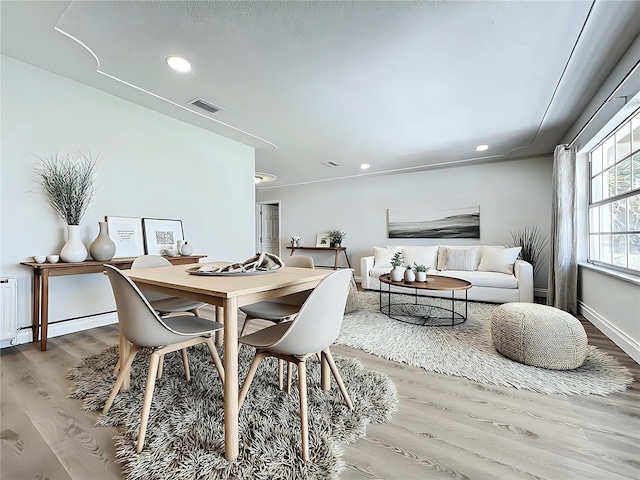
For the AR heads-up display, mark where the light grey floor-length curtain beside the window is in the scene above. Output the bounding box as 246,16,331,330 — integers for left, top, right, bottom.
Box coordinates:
547,145,578,313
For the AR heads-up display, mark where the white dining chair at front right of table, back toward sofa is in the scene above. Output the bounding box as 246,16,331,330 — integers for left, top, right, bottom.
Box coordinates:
239,270,353,461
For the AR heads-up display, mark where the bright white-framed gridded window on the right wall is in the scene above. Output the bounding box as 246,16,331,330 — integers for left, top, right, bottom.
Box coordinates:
589,110,640,274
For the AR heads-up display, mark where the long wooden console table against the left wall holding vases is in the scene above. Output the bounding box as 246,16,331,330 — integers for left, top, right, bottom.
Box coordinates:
20,255,206,352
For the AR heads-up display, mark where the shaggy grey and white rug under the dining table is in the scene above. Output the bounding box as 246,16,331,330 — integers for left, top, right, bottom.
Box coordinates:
69,345,397,480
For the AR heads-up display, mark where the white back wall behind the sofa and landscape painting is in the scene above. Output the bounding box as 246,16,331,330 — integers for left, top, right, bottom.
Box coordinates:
256,156,552,291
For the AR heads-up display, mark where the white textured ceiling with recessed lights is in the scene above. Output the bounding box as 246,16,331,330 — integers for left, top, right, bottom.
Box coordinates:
0,0,640,186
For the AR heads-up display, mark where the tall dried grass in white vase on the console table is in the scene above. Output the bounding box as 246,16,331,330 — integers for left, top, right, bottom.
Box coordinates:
35,152,100,262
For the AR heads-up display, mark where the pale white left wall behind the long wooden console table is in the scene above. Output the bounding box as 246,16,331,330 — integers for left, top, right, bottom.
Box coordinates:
0,56,255,340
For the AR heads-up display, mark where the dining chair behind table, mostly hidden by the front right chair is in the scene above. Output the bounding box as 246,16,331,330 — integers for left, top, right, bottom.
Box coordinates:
240,255,314,393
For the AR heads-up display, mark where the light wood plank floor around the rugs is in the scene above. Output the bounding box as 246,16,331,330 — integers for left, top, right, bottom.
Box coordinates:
0,312,640,480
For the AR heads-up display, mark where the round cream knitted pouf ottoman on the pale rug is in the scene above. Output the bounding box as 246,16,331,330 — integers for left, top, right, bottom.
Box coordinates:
491,302,587,370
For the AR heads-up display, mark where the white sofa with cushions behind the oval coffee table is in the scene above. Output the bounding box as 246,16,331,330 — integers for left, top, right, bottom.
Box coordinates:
360,245,533,303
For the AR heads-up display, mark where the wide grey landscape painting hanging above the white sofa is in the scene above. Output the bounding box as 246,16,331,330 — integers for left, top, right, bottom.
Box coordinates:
387,205,480,238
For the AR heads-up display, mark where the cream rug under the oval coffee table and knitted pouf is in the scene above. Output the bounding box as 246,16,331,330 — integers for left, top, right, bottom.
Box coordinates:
336,292,633,395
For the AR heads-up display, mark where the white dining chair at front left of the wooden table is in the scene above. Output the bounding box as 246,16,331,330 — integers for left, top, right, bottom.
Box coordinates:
102,265,224,453
